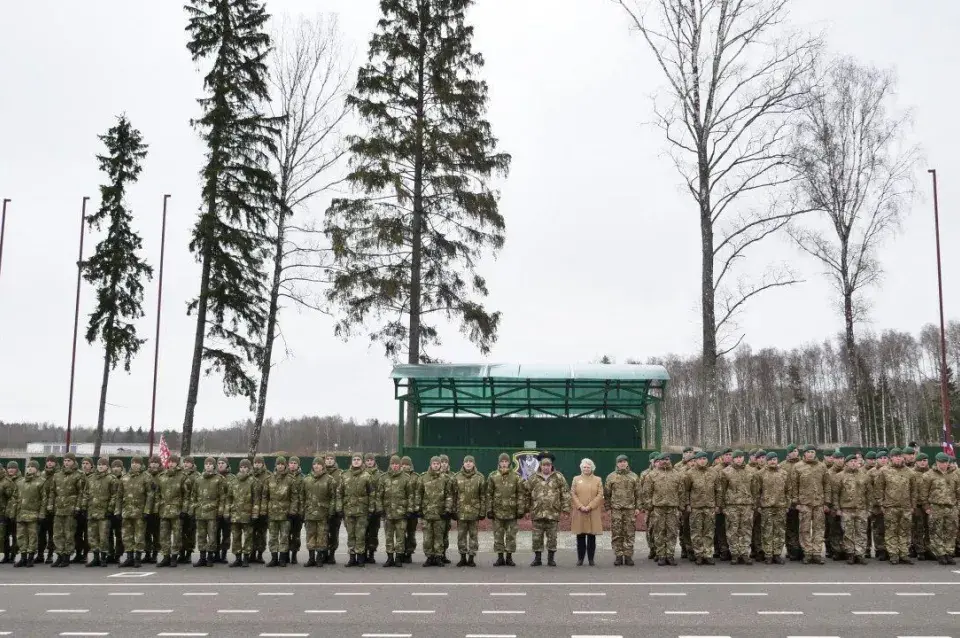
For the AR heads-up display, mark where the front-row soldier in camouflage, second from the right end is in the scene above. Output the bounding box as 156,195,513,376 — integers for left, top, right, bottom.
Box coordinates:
873,448,918,565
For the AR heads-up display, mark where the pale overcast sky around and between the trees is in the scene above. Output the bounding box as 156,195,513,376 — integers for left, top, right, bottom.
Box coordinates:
0,0,960,436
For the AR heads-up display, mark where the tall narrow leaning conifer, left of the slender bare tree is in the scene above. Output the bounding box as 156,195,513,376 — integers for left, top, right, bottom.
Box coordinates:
180,0,277,454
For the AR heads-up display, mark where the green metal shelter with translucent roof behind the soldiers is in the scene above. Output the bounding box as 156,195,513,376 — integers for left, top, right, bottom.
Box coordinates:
391,363,670,476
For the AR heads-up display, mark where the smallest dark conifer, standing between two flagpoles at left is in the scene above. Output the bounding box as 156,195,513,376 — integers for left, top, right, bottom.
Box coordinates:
82,115,153,457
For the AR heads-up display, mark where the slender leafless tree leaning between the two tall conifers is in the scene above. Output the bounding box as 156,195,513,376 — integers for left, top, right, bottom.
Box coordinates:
249,16,348,454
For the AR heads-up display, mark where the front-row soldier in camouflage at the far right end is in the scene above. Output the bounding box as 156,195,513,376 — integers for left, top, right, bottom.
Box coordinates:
917,452,960,565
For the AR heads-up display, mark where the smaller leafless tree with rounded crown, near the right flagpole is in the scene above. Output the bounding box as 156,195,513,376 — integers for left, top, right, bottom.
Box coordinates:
790,58,918,440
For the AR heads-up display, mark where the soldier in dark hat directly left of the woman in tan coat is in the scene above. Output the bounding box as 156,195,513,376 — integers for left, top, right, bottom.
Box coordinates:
526,453,570,567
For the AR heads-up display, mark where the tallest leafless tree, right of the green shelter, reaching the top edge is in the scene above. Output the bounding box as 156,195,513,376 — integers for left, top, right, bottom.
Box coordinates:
613,0,821,442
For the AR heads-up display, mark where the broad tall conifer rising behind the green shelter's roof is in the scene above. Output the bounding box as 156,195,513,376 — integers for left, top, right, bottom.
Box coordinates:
326,0,510,440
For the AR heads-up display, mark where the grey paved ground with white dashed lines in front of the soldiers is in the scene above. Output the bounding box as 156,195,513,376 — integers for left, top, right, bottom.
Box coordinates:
0,534,960,638
